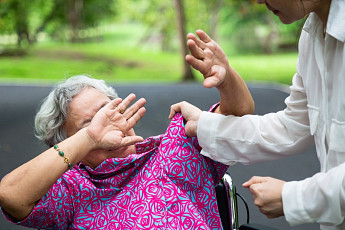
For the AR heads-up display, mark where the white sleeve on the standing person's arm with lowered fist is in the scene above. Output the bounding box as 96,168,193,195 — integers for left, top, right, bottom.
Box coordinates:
282,163,345,226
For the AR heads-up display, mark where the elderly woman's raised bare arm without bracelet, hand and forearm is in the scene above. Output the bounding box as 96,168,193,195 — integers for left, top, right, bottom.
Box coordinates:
186,30,254,116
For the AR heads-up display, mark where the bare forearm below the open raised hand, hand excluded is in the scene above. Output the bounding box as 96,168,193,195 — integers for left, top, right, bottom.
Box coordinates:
215,66,255,116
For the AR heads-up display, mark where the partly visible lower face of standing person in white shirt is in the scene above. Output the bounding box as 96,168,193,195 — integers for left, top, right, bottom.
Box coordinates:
257,0,304,24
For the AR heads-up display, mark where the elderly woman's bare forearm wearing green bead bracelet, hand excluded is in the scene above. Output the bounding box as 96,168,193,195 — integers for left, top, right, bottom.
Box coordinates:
0,130,92,220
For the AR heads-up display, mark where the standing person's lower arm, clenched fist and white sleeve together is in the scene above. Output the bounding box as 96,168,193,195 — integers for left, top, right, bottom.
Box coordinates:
243,163,345,226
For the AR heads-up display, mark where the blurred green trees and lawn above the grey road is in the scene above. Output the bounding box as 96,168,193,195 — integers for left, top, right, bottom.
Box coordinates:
0,0,303,83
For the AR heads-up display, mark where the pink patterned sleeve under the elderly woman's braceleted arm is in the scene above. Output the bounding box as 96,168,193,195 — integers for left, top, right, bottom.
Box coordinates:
2,178,73,229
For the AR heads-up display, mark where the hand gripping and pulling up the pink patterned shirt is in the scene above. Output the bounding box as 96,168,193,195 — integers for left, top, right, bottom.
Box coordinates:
169,101,202,137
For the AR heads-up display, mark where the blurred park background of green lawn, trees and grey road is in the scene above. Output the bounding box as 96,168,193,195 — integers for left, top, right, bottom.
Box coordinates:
0,0,319,230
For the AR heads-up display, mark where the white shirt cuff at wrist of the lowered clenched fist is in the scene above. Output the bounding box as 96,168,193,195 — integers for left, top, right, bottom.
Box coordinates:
282,181,314,226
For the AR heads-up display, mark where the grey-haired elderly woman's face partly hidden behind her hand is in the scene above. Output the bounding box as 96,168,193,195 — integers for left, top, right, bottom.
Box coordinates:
64,88,136,168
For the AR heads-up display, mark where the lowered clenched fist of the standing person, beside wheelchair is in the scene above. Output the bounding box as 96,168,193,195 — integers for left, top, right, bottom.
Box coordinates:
243,176,285,218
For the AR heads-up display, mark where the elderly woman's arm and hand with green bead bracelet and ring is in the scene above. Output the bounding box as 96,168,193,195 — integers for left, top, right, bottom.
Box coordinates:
0,94,145,220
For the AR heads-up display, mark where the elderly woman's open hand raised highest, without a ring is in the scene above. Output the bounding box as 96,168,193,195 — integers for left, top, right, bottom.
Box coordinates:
186,30,230,88
